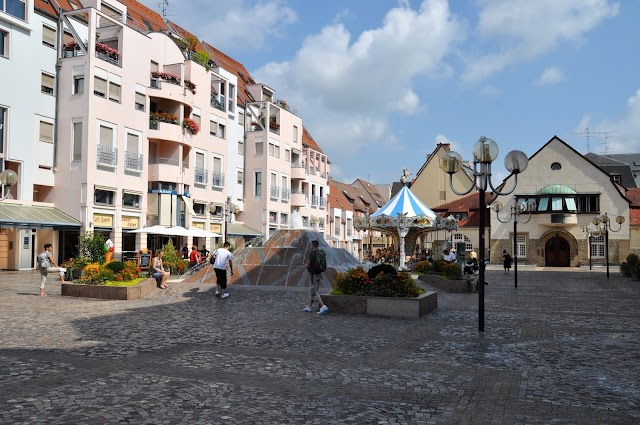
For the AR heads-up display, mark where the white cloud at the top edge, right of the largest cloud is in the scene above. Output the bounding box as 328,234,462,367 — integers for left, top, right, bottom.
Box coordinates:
463,0,620,83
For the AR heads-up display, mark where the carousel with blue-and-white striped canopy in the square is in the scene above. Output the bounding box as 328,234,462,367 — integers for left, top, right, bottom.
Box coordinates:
353,169,458,270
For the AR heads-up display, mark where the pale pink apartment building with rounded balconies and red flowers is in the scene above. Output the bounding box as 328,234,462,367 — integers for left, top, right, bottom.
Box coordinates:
53,0,230,253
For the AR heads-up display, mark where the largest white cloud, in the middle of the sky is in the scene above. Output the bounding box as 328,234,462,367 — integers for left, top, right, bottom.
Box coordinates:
252,0,466,161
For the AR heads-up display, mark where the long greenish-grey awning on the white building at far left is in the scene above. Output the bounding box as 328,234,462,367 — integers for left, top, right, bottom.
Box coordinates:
0,203,82,230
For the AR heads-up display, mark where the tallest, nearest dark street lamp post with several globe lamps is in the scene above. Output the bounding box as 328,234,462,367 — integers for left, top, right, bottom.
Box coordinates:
440,136,529,332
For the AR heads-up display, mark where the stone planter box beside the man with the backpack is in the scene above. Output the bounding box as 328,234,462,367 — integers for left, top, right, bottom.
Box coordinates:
322,291,438,317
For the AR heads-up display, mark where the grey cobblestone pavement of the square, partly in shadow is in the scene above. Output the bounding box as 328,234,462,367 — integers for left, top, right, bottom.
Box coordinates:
0,267,640,424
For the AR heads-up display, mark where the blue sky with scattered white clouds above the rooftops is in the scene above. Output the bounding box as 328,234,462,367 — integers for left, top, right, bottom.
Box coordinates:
142,0,640,184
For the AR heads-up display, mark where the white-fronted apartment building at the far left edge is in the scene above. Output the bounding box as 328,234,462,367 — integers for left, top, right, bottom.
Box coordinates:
0,0,80,270
